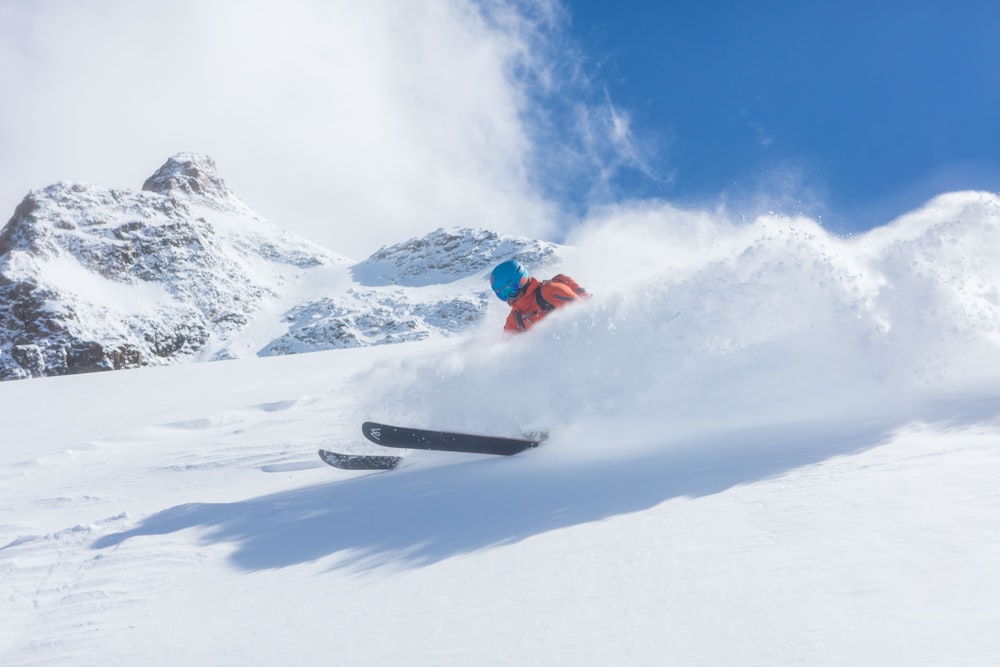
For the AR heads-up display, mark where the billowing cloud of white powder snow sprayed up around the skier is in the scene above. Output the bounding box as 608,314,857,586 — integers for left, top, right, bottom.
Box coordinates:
360,193,1000,442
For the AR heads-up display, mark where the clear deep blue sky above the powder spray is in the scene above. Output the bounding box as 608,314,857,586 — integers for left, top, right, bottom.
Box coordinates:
565,0,1000,232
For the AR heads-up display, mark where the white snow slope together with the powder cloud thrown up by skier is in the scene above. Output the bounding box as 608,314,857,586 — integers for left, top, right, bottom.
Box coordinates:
0,193,1000,665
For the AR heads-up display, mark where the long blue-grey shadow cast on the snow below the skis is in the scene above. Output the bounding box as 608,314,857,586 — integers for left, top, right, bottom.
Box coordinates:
93,414,932,570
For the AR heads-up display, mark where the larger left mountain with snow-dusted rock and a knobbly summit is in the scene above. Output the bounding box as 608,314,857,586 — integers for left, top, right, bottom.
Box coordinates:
0,154,347,379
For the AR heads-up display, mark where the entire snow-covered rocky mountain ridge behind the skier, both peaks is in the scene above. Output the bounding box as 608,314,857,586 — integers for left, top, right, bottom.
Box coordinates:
0,154,557,379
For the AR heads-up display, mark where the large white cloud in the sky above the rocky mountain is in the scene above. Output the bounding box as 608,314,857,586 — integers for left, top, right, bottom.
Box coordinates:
0,0,648,258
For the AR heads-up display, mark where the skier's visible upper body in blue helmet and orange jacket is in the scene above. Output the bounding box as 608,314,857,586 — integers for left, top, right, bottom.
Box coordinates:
490,259,590,333
